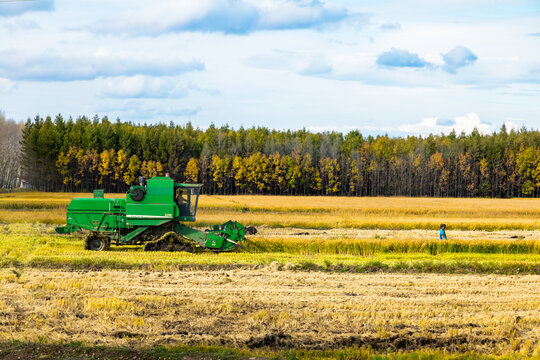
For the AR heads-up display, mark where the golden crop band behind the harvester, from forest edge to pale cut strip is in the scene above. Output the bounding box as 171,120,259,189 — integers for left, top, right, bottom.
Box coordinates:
0,192,540,231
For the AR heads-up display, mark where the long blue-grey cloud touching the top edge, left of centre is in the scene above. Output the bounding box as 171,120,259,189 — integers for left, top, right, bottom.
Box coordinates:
86,0,351,36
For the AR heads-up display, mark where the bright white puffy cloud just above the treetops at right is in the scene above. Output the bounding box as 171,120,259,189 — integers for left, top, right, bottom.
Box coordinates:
399,113,493,135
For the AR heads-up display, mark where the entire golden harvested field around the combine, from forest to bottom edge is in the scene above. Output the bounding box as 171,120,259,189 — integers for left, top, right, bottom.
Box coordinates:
0,193,540,359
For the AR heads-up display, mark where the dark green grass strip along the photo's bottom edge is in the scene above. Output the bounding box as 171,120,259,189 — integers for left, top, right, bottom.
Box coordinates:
0,341,534,360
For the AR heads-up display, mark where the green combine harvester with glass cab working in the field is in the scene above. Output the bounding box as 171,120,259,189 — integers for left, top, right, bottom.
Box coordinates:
56,177,246,252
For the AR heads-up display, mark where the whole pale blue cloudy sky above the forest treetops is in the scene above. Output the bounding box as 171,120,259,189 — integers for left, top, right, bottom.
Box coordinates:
0,0,540,136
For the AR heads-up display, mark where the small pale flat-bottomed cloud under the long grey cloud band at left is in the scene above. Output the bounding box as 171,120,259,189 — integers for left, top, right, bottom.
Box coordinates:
101,75,188,98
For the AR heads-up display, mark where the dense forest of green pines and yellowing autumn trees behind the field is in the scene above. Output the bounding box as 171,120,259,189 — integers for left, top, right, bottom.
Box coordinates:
6,115,540,198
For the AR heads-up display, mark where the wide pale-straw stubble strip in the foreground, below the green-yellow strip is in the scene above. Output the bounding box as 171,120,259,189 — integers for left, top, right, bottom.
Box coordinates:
0,264,540,355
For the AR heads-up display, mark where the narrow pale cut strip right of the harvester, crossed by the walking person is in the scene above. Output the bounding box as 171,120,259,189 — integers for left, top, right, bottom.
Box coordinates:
252,226,540,240
